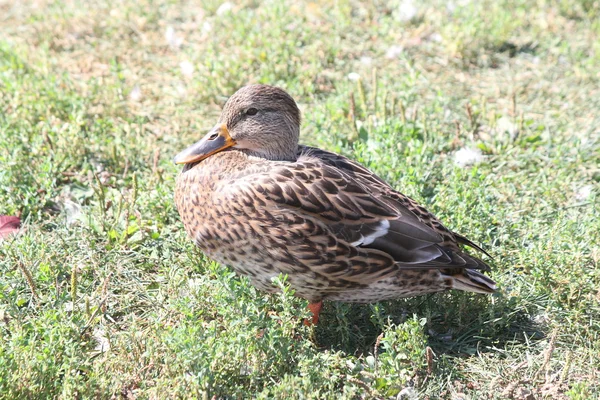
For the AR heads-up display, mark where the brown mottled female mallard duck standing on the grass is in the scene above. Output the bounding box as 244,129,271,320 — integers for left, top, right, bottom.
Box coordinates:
174,85,496,323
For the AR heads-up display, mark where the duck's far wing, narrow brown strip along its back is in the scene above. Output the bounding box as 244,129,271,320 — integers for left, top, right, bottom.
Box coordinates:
298,146,492,260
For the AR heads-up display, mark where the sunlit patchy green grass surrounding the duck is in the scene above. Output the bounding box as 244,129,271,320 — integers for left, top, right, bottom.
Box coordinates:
0,0,600,399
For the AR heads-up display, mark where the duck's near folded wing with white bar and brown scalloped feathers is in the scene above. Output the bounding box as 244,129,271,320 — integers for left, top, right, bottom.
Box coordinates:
224,158,494,284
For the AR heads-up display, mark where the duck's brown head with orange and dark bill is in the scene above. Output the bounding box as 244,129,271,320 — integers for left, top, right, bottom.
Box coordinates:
174,85,300,164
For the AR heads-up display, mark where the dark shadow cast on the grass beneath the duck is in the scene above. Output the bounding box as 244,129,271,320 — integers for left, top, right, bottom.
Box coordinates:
315,292,546,356
